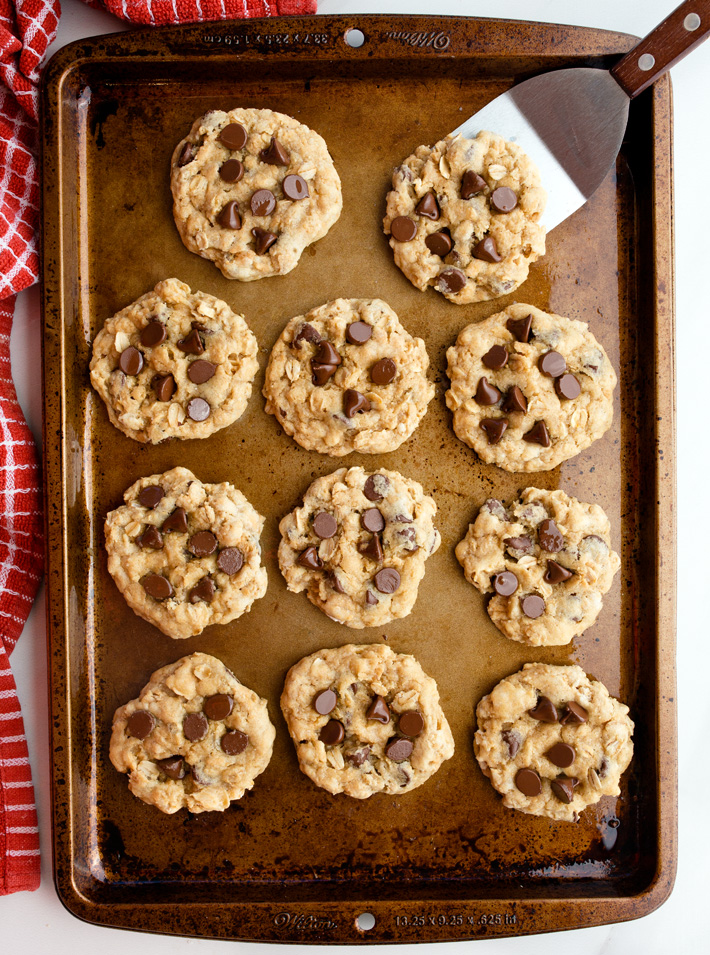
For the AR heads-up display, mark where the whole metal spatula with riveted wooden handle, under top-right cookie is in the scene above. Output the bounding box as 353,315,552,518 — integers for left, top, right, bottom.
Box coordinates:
454,0,710,231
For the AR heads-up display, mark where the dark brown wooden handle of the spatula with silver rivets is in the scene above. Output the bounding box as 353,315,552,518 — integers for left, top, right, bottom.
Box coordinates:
611,0,710,99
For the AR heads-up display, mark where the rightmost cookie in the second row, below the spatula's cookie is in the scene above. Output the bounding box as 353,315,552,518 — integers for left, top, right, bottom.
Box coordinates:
446,304,616,471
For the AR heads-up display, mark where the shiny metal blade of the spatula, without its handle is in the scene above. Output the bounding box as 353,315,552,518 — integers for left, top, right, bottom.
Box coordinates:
453,67,630,232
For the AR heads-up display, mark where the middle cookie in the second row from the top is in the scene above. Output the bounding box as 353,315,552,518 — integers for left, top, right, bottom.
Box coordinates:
264,298,434,457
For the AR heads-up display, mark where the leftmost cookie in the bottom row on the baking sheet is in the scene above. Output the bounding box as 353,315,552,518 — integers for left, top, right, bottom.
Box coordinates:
109,653,276,813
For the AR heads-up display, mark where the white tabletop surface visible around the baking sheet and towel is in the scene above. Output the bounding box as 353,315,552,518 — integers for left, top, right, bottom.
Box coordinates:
0,0,710,955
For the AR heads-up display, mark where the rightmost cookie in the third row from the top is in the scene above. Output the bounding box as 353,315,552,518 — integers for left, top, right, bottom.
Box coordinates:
456,487,621,647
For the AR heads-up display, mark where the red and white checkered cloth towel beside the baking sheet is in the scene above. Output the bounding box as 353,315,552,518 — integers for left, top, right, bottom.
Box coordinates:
0,0,316,895
